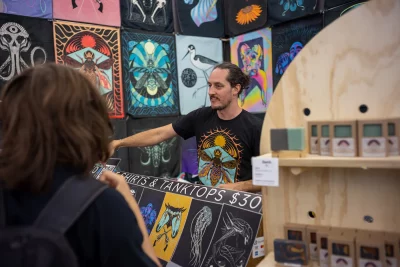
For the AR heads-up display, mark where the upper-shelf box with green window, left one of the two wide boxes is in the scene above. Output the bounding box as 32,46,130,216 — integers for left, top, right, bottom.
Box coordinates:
329,121,358,157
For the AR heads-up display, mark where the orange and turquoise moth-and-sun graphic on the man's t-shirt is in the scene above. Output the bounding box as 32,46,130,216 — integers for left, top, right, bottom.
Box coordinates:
198,128,242,186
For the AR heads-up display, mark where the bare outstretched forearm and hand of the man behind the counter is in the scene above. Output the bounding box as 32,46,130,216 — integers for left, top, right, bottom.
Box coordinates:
110,124,177,154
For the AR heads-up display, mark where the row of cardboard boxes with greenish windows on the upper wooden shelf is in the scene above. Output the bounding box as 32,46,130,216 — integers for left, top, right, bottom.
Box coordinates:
308,119,400,157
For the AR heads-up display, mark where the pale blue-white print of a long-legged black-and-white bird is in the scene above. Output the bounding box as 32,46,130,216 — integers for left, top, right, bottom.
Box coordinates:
176,35,223,115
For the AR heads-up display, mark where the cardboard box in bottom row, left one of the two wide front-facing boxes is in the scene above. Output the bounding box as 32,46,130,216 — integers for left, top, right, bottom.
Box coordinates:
328,232,356,267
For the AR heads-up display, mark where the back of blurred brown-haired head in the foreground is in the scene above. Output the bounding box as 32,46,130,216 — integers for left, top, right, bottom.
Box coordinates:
0,63,112,192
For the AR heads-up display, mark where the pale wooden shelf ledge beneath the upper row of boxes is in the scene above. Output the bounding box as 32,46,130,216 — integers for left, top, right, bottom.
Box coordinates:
262,154,400,169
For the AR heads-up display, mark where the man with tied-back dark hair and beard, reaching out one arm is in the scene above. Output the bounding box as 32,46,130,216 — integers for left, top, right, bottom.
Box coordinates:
110,62,263,192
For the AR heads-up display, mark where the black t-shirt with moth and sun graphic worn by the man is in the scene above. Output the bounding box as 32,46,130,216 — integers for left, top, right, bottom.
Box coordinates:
172,107,263,186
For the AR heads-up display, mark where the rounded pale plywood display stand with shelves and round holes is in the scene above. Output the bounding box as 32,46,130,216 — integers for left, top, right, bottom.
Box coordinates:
258,0,400,266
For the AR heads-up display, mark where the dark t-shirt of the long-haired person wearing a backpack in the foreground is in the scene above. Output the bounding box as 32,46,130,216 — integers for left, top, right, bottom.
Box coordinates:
0,168,156,267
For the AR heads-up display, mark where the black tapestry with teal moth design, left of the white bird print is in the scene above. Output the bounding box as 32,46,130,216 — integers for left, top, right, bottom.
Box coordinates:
121,29,179,117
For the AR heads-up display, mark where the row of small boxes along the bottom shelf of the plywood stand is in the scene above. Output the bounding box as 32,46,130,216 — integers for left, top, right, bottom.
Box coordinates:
274,224,400,267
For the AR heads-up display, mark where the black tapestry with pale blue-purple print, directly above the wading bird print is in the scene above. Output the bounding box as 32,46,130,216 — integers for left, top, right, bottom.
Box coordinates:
174,0,225,38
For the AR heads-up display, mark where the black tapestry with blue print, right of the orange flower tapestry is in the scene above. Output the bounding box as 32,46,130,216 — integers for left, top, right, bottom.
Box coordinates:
267,0,321,26
